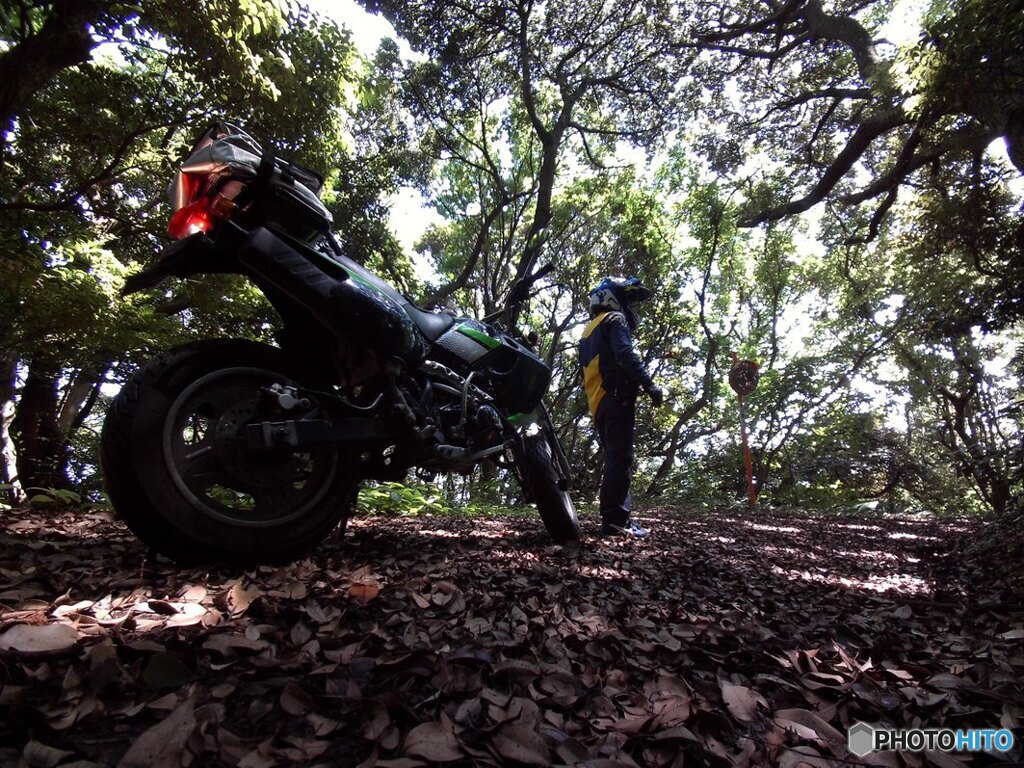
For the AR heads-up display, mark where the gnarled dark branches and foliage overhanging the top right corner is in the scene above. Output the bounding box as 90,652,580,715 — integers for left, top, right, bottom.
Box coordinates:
690,0,1024,240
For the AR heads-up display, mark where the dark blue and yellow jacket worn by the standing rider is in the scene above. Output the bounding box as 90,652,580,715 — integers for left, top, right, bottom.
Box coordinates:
580,312,653,416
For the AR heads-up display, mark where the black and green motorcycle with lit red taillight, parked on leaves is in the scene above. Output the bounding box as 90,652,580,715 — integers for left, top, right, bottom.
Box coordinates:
100,123,580,563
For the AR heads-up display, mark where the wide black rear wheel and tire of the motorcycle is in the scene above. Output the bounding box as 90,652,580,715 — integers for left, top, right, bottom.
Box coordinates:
100,339,358,564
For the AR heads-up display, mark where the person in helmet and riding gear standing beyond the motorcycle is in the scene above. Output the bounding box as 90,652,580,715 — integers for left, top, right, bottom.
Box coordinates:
580,278,665,538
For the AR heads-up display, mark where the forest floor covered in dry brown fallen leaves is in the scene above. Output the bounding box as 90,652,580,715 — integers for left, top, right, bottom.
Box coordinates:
0,509,1024,768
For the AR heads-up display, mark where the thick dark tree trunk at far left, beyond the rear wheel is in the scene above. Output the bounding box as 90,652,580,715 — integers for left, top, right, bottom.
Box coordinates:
10,357,72,489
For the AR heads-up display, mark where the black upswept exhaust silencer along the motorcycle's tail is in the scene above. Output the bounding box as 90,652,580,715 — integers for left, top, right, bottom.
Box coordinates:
238,226,427,360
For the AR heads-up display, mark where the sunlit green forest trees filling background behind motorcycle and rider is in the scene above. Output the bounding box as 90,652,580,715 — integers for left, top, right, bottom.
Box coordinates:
0,0,1024,515
